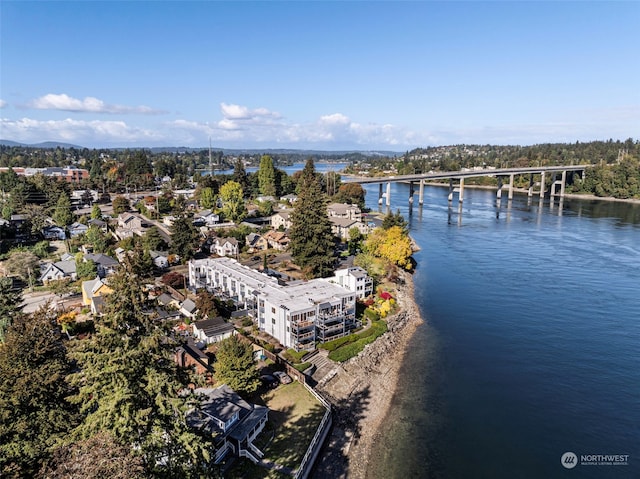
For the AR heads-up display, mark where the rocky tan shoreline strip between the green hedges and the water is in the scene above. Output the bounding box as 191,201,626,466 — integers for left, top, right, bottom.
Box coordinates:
312,272,423,478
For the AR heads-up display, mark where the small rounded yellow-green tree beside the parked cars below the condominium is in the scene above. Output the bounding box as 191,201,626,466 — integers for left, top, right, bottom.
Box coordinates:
214,335,260,396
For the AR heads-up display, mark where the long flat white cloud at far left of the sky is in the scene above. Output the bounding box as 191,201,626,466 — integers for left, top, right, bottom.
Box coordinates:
27,93,166,115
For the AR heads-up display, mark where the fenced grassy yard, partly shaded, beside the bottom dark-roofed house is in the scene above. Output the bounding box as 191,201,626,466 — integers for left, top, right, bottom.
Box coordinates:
225,381,325,478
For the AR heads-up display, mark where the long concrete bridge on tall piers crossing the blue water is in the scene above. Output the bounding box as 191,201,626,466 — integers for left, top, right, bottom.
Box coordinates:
348,165,591,206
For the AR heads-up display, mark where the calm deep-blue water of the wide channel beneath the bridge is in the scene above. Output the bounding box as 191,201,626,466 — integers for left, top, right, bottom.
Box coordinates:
367,185,640,479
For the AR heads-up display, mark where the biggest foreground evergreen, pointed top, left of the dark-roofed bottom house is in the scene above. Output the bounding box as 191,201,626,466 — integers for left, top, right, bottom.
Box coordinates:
71,268,213,477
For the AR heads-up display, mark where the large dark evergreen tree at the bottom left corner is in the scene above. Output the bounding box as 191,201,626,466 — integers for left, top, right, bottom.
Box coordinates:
0,308,78,478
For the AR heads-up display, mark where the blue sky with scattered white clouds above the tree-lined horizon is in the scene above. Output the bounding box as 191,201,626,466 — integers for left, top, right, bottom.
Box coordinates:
0,0,640,151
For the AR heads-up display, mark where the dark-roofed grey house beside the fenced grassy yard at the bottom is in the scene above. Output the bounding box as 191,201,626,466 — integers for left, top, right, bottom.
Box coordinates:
186,384,269,463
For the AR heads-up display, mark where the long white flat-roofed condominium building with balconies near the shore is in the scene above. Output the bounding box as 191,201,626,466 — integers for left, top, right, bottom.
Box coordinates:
189,258,359,351
